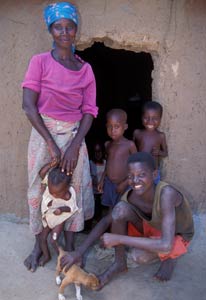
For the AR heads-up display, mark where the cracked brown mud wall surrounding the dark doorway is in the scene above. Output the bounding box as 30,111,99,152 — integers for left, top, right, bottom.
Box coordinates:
0,0,206,217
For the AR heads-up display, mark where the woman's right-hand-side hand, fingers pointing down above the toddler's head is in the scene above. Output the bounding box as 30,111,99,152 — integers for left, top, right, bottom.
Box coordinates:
60,143,80,175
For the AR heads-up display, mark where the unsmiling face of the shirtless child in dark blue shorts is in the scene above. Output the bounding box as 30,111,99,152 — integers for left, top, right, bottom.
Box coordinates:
106,115,128,141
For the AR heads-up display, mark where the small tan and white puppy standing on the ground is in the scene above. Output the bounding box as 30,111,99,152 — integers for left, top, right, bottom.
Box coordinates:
56,247,99,300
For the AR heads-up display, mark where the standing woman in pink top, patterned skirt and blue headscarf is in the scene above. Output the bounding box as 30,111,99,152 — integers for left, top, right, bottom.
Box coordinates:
22,2,97,271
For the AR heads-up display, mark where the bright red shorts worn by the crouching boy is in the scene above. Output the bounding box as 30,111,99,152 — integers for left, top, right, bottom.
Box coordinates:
128,221,190,260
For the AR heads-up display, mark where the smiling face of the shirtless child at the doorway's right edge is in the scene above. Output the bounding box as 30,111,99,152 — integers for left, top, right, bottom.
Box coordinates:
142,109,161,131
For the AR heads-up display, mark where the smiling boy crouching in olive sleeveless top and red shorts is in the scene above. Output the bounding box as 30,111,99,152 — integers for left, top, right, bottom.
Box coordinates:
99,152,194,287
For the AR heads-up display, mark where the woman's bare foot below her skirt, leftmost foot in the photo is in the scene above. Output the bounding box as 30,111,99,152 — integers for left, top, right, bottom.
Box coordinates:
24,239,42,272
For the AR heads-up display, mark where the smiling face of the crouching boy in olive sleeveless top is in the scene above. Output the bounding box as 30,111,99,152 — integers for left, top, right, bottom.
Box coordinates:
128,162,156,195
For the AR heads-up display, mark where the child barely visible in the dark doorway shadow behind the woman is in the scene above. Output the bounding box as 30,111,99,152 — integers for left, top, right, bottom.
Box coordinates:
90,142,106,221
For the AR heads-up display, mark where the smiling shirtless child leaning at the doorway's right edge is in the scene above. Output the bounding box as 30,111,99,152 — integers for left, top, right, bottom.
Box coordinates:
133,101,168,183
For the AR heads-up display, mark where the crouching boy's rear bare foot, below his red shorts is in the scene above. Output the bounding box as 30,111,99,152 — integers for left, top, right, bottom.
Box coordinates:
154,258,177,281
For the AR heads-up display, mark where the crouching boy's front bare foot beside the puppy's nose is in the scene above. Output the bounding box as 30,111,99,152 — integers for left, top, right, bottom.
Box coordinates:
97,262,127,290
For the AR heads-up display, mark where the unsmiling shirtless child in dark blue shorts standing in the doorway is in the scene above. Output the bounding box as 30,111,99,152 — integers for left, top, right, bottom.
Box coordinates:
98,109,137,209
